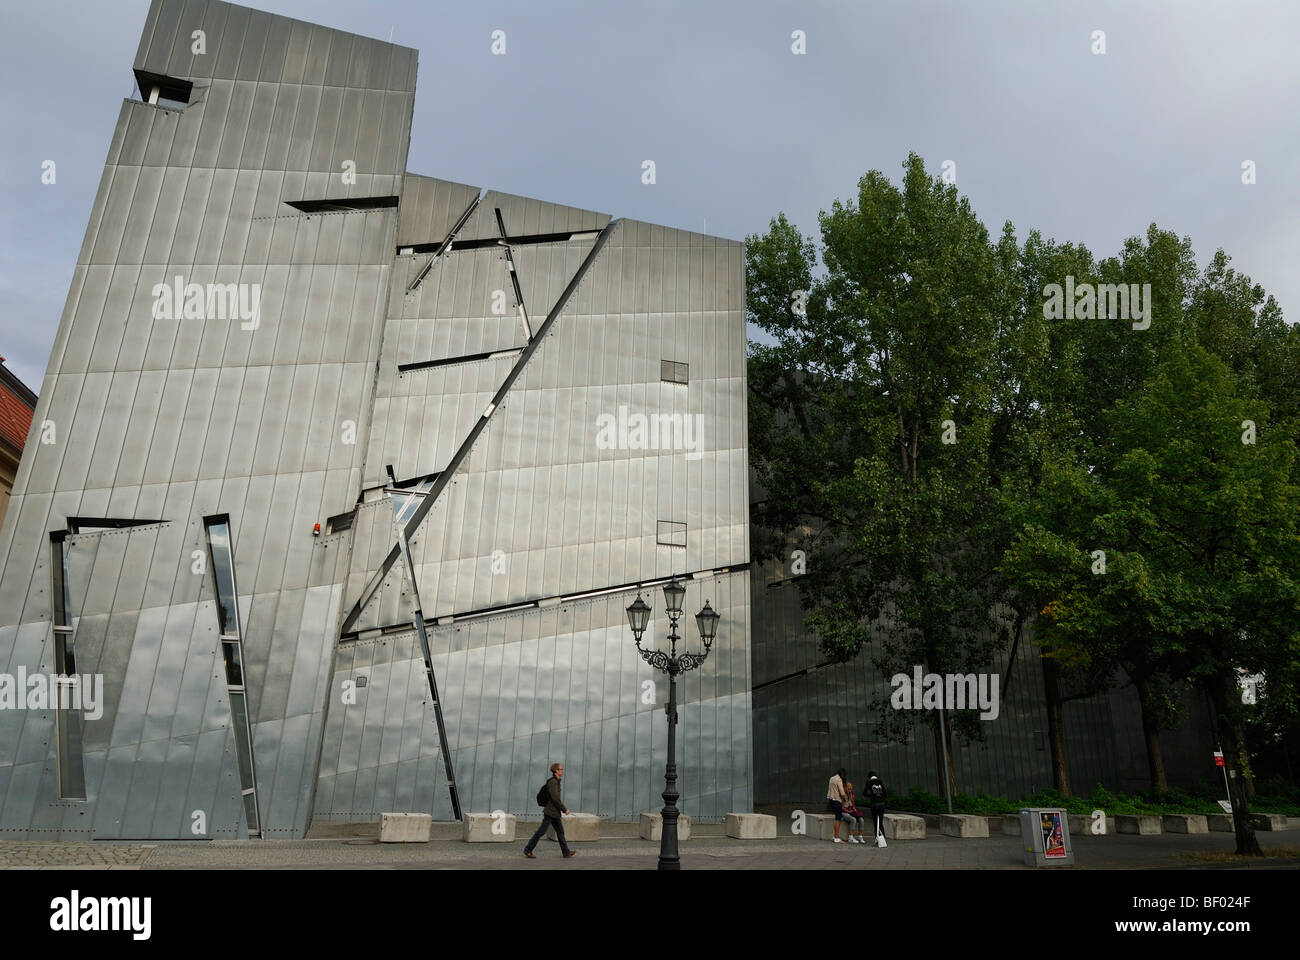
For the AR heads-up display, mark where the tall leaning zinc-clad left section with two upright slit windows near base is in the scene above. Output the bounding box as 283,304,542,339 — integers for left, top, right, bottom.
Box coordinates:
0,0,416,838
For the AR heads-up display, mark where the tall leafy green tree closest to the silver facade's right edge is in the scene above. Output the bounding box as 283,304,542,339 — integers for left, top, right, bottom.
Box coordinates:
746,155,1008,792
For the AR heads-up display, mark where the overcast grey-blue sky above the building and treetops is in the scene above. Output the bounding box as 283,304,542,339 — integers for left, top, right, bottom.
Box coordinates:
0,0,1300,389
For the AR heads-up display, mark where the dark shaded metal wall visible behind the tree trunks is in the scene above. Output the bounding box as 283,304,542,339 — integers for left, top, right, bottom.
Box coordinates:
751,548,1213,804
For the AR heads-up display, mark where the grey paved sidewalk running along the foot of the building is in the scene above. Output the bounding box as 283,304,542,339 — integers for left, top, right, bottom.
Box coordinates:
0,830,1300,870
